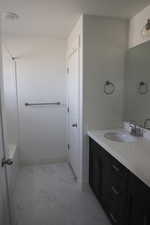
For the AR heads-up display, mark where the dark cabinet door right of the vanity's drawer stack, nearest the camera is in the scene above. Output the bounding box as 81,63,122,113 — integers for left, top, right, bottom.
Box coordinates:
129,176,150,225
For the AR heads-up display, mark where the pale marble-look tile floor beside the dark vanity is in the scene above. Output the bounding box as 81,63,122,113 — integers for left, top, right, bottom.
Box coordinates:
13,163,110,225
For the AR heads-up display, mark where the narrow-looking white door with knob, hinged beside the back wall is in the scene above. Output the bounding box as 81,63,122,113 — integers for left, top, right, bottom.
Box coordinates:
68,39,80,179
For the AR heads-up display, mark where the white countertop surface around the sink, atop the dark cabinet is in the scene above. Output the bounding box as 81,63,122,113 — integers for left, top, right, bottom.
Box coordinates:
88,129,150,187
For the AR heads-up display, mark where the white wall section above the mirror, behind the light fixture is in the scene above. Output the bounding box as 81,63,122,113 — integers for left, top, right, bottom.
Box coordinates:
129,6,150,48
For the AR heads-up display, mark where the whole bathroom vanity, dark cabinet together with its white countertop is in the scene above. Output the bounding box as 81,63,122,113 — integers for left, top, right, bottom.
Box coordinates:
88,131,150,225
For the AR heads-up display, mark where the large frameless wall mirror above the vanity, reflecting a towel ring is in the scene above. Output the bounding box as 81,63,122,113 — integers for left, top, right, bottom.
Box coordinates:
124,41,150,129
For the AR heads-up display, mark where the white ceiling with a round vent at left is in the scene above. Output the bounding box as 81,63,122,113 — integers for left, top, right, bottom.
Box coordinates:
0,0,150,38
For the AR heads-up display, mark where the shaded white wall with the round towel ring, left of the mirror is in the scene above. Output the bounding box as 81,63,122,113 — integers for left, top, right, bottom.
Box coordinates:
83,16,128,129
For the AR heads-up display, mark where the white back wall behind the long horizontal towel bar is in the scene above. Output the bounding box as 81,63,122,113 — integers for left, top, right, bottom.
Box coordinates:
6,37,66,164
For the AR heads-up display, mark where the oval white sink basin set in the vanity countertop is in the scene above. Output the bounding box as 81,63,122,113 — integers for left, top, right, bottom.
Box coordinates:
104,131,138,142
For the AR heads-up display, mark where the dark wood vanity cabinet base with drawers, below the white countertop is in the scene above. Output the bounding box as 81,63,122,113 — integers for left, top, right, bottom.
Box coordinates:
89,138,150,225
